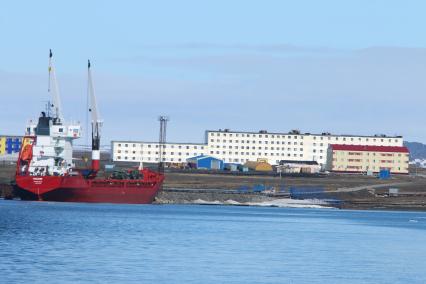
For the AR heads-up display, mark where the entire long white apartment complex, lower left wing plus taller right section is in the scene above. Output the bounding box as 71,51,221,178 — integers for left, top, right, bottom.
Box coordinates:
111,129,403,167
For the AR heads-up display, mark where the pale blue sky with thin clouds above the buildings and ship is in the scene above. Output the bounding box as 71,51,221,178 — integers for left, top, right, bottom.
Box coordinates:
0,0,426,144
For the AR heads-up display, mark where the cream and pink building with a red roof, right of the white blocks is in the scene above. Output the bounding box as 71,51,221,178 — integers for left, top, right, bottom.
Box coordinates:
327,144,409,174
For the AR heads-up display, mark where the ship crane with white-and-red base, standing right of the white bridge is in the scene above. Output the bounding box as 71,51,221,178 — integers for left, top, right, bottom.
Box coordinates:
87,60,103,172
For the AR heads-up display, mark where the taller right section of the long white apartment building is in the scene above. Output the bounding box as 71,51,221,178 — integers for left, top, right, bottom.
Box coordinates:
206,129,403,167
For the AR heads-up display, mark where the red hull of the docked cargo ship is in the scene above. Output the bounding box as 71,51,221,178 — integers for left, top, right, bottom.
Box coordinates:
15,173,164,204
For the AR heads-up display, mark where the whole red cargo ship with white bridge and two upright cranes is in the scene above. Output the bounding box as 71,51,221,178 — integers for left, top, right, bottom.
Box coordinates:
14,51,164,204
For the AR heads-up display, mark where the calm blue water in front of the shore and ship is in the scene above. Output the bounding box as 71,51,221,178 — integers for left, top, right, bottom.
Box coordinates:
0,200,426,283
